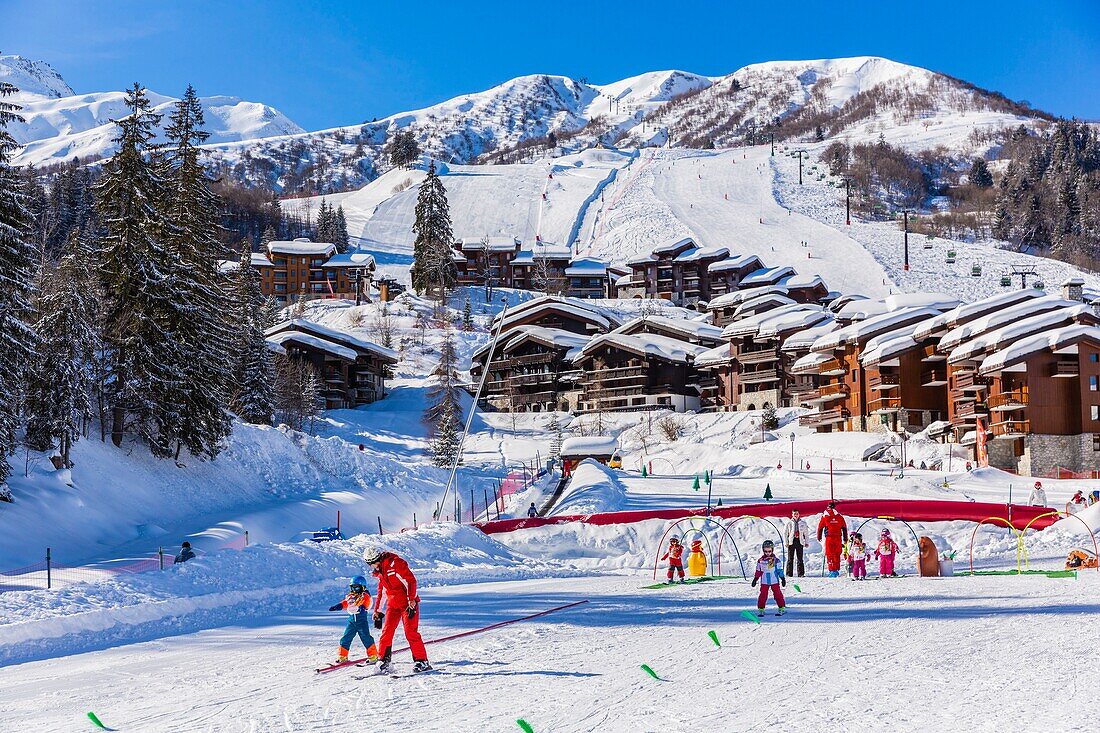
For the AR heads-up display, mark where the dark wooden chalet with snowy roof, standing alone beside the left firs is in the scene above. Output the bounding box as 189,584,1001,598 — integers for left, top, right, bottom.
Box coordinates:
265,318,397,409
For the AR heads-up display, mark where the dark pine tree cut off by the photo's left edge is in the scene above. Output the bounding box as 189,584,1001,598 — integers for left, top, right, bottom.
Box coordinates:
0,81,35,488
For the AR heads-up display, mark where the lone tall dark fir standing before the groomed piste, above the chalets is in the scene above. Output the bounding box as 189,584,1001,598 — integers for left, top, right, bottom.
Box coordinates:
410,163,458,299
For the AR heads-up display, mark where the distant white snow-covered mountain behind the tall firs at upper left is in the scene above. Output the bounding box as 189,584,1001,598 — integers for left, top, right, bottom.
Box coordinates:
0,56,303,165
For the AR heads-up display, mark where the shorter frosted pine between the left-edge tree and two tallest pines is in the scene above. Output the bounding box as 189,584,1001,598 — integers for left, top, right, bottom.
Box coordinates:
26,229,99,466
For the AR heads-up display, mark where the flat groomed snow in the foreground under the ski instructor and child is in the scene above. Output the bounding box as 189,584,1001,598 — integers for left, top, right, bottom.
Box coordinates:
0,575,1100,732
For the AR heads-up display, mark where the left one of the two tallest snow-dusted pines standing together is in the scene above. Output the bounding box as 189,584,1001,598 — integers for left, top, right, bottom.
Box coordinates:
95,84,184,457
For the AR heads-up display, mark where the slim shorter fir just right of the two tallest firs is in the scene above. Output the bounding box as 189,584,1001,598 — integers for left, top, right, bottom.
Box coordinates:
230,244,275,425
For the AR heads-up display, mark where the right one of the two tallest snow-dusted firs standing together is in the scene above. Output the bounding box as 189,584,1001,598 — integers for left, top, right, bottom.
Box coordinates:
165,85,232,458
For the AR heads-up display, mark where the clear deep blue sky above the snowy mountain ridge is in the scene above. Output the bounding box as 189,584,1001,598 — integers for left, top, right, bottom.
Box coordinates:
0,0,1100,129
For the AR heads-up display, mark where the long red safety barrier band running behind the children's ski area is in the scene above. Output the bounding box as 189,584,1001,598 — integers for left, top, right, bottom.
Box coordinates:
475,499,1055,535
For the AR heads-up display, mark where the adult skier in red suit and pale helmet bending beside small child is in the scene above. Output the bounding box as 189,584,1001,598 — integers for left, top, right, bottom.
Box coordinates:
363,539,431,675
